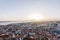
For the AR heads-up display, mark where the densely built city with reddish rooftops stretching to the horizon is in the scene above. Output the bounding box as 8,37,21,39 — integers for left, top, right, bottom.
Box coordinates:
0,21,60,40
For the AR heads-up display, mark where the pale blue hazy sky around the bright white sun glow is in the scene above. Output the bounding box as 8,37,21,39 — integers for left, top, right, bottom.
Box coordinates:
0,0,60,21
